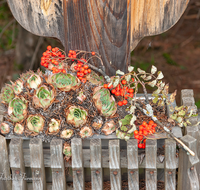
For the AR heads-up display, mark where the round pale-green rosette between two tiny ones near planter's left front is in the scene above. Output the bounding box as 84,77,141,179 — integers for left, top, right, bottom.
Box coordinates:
26,114,44,133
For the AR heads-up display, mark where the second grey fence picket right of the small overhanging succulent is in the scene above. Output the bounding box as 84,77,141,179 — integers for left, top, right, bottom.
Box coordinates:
90,139,103,190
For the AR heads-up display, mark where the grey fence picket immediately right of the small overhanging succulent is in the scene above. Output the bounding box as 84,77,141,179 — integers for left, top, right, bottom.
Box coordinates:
71,138,85,190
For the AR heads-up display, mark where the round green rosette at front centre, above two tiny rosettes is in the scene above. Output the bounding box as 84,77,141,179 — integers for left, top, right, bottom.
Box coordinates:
65,106,88,127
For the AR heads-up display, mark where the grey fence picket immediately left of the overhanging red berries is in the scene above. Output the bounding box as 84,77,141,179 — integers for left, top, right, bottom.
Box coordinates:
127,139,139,190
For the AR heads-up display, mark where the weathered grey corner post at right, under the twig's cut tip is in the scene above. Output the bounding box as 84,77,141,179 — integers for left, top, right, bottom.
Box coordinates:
178,135,199,190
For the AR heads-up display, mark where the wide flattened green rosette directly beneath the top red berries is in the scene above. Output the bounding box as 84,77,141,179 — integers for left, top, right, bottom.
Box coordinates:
47,73,80,92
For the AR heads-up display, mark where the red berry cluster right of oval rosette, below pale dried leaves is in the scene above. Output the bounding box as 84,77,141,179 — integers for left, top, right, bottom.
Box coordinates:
104,78,134,106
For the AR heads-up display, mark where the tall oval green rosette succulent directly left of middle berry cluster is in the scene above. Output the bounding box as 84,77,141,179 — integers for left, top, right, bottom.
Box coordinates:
93,86,117,117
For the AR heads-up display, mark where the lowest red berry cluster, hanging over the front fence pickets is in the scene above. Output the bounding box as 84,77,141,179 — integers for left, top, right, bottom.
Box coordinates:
134,120,157,148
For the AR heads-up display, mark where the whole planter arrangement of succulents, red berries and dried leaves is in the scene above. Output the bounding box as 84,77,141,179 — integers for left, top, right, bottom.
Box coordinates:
0,46,197,160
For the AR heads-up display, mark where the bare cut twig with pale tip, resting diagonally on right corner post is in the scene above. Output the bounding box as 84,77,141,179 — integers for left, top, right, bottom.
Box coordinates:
135,103,195,156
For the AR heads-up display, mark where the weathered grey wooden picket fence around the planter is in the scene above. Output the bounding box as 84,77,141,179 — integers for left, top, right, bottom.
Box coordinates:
0,90,200,190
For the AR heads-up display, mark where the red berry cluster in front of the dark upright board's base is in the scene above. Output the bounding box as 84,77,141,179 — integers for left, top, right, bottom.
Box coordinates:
74,58,91,83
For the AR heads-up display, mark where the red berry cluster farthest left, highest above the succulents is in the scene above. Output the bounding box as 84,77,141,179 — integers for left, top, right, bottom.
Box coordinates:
40,46,66,73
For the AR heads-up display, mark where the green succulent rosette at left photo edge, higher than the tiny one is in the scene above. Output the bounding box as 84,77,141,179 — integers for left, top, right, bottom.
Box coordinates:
0,84,15,104
